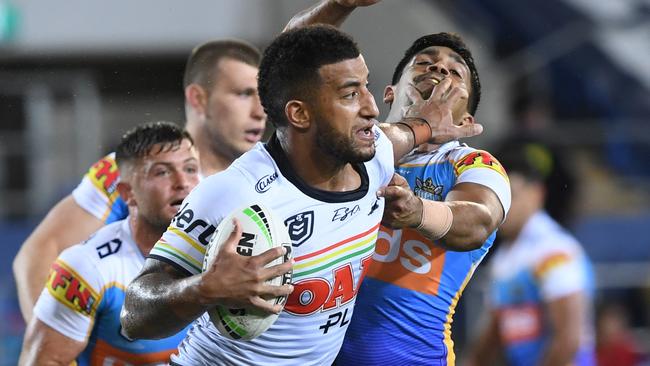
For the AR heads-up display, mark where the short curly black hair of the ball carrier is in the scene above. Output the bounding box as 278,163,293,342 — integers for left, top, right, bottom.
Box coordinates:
258,25,360,128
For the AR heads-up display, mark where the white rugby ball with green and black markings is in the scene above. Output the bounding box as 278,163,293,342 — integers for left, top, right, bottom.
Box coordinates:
203,204,291,340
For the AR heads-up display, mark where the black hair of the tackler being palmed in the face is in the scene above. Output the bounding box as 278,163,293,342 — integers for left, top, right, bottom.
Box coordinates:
392,32,481,115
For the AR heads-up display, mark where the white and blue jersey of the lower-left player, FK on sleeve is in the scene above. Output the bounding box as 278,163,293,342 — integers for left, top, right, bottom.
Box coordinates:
34,219,185,366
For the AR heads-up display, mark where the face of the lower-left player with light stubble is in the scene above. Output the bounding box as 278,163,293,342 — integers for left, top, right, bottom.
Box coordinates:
132,139,199,231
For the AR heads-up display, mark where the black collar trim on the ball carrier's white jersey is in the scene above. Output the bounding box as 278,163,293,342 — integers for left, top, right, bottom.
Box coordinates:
264,133,369,203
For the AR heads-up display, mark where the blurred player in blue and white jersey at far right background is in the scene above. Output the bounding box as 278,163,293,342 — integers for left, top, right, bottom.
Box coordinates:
469,142,595,366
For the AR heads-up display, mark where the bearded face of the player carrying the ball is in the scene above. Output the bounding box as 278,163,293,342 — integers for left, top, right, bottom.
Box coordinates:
314,55,379,163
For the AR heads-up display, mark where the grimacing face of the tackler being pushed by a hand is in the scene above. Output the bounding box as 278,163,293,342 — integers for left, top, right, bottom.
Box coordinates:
384,46,472,123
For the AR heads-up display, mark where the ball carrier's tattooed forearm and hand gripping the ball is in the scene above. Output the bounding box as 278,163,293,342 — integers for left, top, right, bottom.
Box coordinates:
120,222,293,339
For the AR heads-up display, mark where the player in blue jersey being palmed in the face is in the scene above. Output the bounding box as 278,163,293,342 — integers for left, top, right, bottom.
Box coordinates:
287,0,510,365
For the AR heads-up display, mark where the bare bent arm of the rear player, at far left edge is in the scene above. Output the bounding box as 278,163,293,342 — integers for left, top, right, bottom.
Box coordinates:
13,195,104,323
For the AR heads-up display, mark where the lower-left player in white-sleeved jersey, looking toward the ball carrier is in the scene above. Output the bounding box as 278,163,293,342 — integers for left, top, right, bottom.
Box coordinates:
20,122,199,365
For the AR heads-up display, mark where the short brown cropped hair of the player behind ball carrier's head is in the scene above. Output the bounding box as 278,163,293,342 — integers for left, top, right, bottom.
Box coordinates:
183,39,262,90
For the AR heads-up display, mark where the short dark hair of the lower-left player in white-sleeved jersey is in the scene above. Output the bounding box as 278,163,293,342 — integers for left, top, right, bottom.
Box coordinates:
115,121,194,169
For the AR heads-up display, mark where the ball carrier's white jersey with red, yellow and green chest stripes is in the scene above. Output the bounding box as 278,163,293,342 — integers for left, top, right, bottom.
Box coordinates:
149,127,394,366
